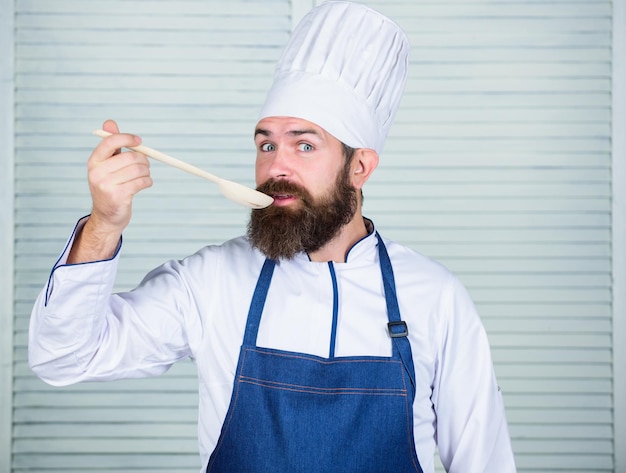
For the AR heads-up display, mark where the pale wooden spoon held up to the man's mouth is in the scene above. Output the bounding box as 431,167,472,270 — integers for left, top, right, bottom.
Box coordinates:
93,130,274,209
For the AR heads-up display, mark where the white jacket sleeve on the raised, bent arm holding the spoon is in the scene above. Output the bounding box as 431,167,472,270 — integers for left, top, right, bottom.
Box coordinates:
28,219,192,386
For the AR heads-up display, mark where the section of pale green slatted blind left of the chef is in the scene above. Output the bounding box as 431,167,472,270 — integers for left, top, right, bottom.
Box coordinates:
13,0,291,473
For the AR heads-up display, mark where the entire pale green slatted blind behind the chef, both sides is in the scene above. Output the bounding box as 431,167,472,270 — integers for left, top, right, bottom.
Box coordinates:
13,0,613,473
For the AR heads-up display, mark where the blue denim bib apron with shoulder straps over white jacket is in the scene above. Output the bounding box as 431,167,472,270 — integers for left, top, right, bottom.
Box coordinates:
206,234,422,473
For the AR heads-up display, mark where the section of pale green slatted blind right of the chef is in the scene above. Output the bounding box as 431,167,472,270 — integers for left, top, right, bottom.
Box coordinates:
365,0,613,473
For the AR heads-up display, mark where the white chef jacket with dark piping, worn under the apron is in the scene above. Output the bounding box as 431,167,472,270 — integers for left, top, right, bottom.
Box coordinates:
29,219,515,473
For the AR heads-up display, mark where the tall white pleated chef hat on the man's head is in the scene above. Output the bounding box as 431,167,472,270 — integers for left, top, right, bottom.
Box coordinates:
259,1,410,154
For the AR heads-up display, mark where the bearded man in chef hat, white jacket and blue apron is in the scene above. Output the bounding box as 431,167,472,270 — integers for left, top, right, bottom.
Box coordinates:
29,1,515,473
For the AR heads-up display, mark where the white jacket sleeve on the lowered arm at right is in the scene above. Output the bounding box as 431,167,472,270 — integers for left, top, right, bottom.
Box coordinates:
432,277,516,473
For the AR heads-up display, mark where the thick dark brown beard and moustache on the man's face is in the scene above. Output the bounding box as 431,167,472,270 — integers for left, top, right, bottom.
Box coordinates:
248,164,358,261
